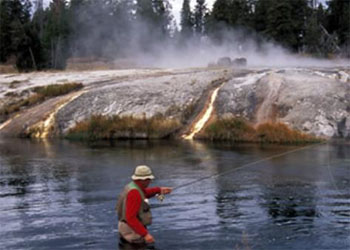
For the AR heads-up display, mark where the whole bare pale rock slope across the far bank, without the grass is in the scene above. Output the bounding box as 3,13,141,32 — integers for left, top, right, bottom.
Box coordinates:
0,67,350,138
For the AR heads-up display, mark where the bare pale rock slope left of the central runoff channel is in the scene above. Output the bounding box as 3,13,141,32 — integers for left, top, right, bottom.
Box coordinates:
0,68,229,137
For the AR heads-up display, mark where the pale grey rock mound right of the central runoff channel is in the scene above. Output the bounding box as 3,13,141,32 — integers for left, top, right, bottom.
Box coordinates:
217,68,350,137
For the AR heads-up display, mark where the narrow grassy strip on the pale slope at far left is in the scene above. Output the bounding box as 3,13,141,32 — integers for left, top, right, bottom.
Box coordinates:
0,82,83,118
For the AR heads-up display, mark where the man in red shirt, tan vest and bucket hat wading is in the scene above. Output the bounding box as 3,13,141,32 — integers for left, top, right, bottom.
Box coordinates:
116,165,172,244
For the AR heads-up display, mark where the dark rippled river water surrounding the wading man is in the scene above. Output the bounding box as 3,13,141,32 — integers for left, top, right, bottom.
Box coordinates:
0,139,350,250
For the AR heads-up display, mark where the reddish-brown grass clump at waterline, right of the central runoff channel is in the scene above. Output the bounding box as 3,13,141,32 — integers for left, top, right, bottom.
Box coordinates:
196,118,321,144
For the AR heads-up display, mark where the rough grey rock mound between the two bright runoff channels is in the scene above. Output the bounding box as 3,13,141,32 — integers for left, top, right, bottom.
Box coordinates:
56,70,227,133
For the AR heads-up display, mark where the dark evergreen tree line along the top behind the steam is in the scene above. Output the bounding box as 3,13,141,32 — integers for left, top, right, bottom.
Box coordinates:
0,0,350,70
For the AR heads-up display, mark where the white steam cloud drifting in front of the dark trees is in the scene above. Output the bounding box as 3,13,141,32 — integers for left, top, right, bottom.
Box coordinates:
71,1,349,68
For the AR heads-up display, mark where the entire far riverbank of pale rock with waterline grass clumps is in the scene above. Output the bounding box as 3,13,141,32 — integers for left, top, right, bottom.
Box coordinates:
0,67,350,143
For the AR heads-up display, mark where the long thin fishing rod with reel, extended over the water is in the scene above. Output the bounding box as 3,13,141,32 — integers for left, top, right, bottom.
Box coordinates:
157,141,328,202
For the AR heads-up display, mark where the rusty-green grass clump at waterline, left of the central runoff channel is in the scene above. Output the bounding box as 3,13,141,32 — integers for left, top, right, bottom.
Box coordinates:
66,114,181,141
